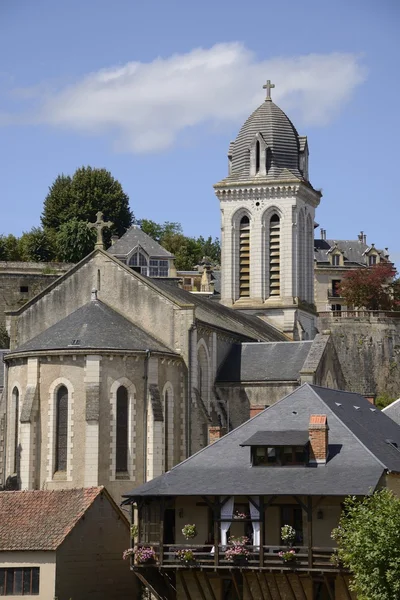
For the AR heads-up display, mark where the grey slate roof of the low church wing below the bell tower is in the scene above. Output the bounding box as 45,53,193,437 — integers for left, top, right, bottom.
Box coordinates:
217,341,312,383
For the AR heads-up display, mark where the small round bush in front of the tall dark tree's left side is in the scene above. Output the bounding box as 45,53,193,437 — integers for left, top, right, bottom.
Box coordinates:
56,219,96,262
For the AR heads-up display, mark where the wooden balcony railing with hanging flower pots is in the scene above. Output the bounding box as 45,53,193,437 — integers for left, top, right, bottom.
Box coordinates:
134,544,341,571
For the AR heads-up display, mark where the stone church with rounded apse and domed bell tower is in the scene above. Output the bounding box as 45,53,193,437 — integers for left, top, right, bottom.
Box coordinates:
0,81,345,502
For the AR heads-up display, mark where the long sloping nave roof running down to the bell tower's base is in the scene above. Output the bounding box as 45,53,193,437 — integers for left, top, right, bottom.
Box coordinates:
151,279,287,341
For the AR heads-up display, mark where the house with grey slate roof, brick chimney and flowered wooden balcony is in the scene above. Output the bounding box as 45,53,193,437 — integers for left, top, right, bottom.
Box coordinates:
125,383,400,600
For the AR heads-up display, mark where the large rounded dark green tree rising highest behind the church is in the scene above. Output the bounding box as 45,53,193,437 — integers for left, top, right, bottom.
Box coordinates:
41,167,133,241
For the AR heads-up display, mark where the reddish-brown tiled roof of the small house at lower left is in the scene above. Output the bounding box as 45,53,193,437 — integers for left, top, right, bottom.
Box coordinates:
0,487,104,552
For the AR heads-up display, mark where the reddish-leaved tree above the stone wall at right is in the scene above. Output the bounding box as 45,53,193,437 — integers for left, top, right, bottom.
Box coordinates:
339,263,400,310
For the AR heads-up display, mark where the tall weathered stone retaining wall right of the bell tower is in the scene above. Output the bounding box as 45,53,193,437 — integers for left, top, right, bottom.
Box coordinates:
319,312,400,398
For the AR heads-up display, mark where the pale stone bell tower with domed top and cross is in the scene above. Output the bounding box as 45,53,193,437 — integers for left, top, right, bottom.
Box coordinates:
214,80,321,339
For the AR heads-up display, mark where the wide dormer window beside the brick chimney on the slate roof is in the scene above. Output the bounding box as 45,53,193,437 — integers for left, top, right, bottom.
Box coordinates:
241,431,309,467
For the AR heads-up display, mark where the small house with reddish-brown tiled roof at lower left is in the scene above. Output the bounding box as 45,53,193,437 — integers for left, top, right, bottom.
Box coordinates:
0,487,137,600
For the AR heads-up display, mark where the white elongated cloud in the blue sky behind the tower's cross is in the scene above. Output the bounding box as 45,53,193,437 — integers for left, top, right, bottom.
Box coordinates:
4,43,366,153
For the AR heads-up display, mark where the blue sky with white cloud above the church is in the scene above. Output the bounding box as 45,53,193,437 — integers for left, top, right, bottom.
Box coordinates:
0,0,400,264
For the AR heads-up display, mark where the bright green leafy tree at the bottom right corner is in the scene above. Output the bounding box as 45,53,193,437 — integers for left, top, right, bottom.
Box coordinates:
332,489,400,600
